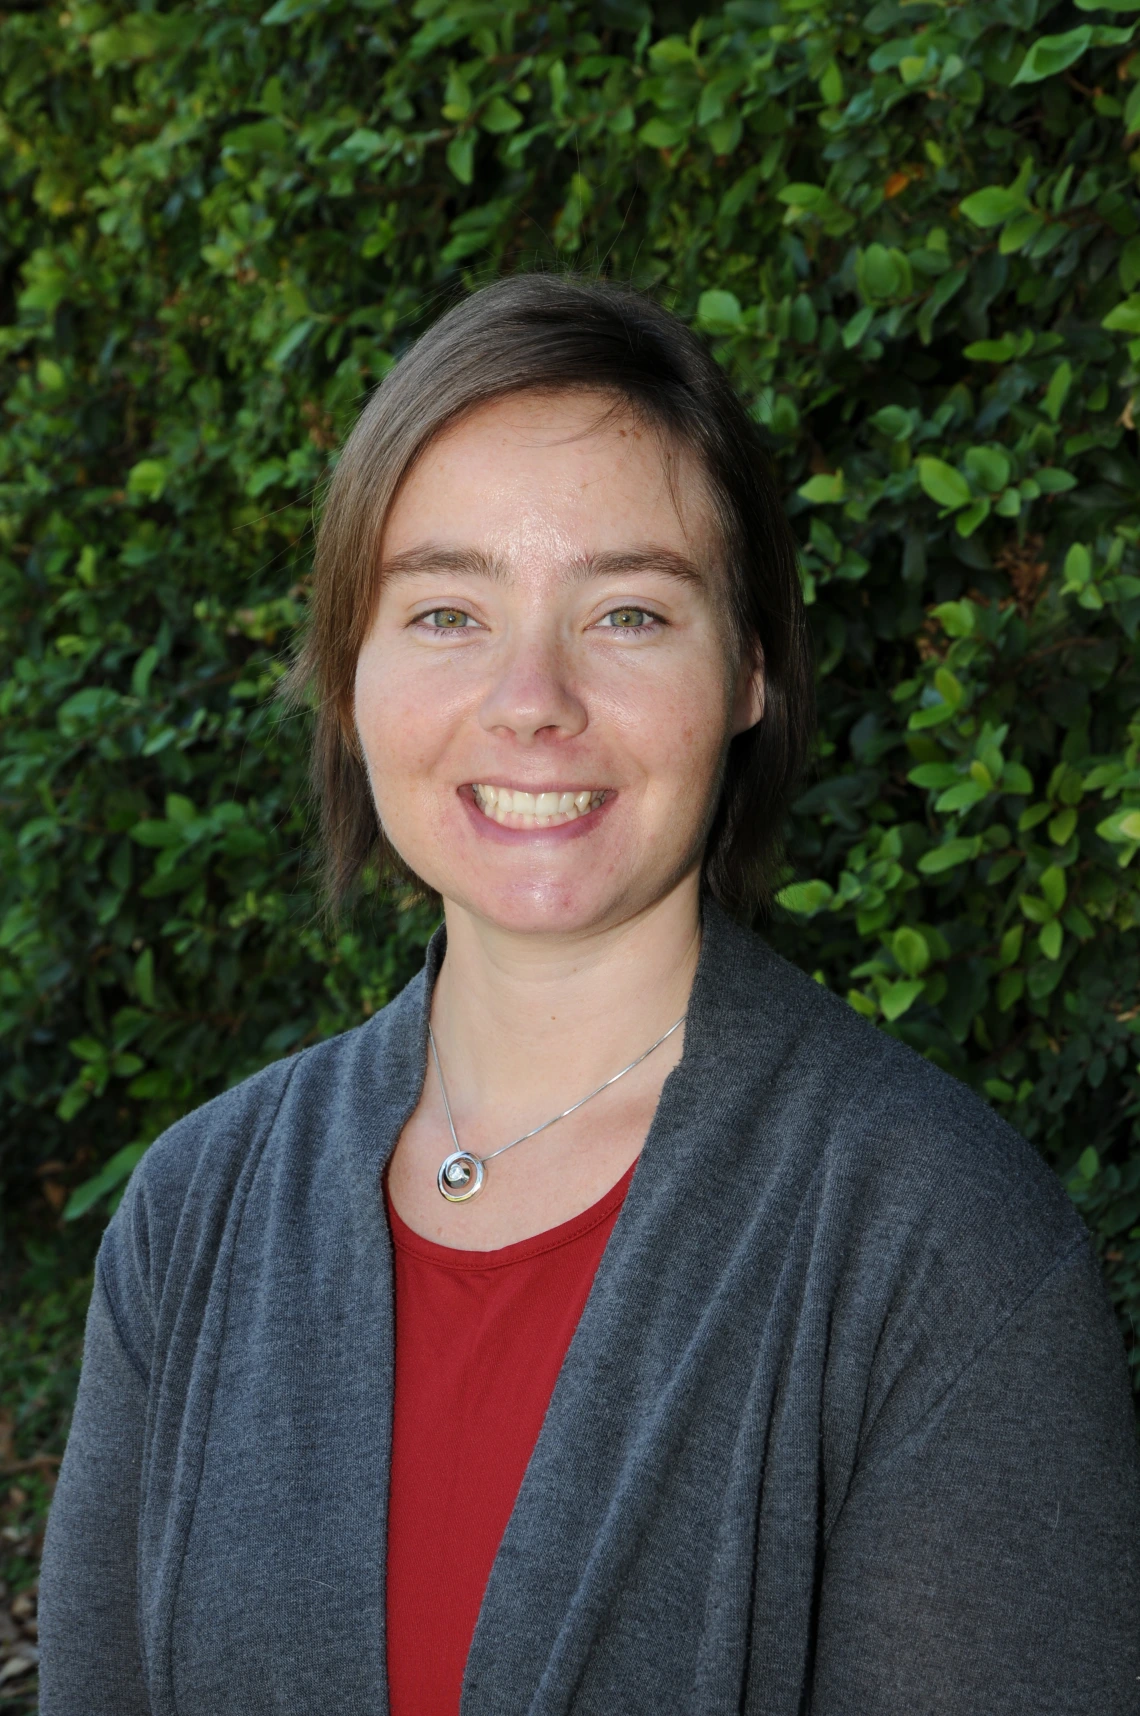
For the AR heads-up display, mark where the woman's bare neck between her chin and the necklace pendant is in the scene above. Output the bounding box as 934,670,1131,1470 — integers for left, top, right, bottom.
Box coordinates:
431,873,700,1109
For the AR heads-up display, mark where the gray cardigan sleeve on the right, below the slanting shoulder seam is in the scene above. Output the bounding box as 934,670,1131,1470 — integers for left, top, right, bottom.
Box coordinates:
810,1239,1140,1716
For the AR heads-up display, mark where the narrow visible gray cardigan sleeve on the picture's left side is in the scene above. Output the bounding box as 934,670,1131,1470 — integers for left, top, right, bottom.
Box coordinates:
39,1273,151,1716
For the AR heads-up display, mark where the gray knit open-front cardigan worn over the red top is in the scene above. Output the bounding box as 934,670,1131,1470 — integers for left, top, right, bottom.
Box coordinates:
41,908,1140,1716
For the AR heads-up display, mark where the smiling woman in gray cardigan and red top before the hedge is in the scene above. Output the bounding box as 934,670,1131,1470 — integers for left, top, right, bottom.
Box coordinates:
41,278,1140,1716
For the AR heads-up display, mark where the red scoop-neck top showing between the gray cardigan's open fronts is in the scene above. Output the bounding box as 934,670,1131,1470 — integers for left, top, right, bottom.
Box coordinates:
386,1167,634,1716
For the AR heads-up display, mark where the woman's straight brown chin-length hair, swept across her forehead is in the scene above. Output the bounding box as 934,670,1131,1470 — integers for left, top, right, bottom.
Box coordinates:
287,275,816,911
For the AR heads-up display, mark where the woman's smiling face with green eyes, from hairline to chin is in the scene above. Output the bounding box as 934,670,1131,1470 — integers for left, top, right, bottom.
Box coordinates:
355,393,762,934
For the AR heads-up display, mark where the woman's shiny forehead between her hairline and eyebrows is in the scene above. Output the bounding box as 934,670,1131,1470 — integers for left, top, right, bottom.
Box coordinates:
383,391,716,561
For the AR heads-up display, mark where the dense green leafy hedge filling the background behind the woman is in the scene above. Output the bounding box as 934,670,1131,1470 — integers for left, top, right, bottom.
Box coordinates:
0,0,1140,1386
